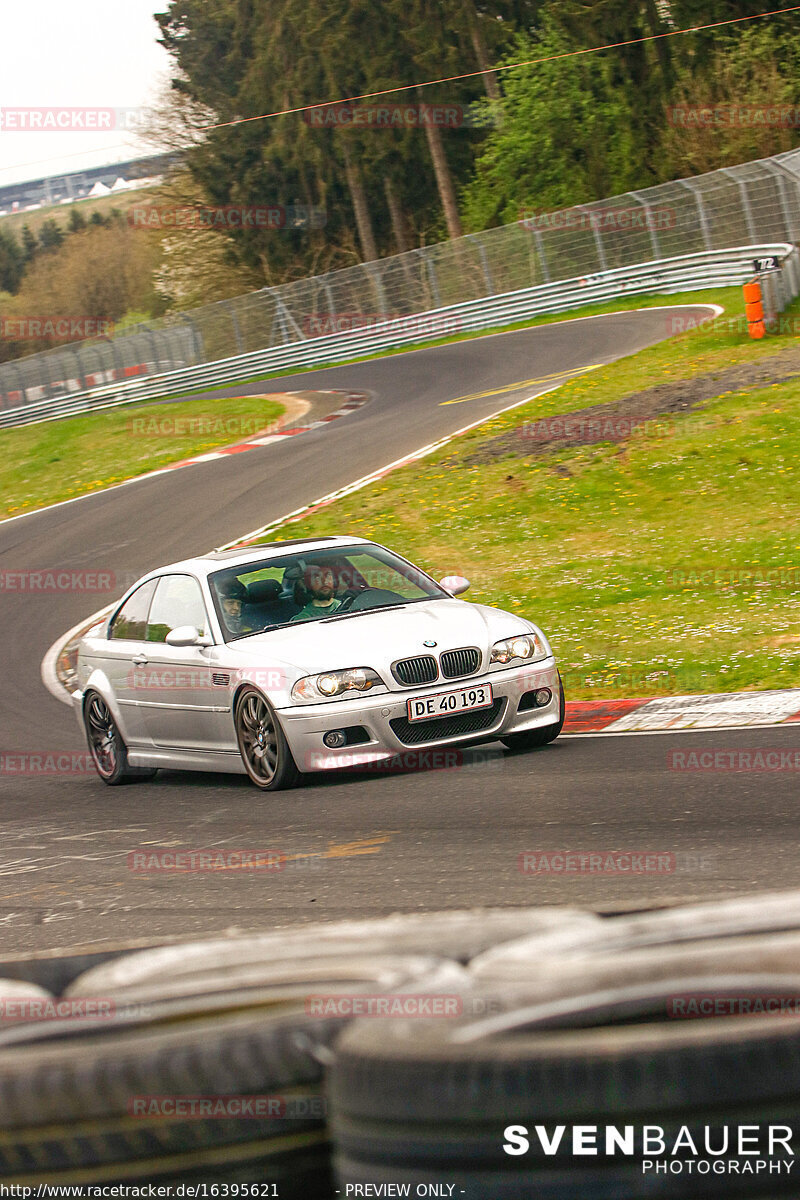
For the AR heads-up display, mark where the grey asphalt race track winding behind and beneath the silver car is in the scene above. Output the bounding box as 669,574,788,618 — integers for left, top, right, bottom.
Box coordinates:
0,308,800,955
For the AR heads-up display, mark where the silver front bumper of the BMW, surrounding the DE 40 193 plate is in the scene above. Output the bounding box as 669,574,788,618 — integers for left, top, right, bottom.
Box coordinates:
278,658,561,772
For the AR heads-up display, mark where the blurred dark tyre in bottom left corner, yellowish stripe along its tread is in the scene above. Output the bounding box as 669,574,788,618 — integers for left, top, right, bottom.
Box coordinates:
0,1006,337,1195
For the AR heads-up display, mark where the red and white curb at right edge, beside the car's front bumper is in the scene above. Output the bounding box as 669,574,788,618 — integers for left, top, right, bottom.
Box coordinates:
564,688,800,734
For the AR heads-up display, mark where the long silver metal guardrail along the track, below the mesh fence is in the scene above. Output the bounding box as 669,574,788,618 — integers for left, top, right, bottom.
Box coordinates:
0,242,800,427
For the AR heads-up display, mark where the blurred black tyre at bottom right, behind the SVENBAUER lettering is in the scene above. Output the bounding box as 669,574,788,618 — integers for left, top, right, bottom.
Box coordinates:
329,950,800,1200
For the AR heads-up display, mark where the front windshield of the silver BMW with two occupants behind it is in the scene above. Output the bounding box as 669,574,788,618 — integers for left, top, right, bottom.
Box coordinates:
209,545,449,642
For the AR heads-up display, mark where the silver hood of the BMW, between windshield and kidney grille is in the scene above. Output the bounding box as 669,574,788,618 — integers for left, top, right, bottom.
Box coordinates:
228,599,531,688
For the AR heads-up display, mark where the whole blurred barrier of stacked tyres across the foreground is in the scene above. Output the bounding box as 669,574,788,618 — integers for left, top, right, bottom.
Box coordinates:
0,892,800,1200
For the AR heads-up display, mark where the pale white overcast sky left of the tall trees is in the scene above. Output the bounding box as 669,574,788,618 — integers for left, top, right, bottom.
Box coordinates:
0,0,170,185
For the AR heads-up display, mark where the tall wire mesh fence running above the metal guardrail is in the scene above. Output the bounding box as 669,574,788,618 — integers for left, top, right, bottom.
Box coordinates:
0,142,800,412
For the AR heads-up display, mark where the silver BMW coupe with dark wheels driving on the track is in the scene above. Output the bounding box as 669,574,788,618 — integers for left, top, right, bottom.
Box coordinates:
73,536,564,791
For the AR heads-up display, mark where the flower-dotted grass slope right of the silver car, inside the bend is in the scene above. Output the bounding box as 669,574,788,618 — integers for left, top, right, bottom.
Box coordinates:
261,291,800,700
